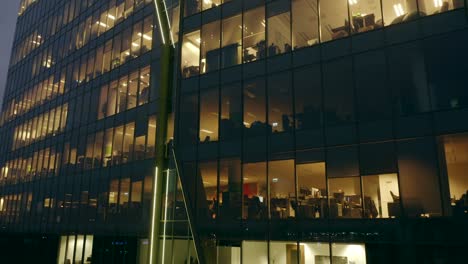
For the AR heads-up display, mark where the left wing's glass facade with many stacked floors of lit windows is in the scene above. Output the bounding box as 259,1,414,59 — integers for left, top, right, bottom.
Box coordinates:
0,0,160,241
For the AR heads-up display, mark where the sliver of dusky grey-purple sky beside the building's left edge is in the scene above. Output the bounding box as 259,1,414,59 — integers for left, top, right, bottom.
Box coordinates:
0,0,20,106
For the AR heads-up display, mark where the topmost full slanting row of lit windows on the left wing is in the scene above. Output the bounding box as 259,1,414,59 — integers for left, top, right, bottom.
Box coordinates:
0,1,154,126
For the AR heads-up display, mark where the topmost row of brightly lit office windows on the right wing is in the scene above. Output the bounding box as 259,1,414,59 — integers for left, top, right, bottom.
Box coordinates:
181,0,464,77
